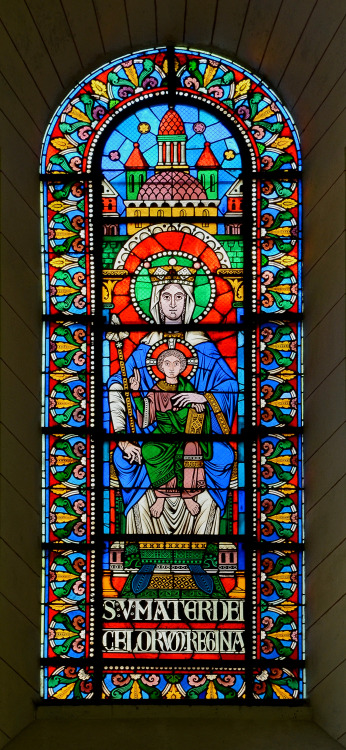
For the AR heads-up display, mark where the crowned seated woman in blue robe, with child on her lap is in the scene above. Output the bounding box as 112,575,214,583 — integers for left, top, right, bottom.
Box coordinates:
108,258,238,535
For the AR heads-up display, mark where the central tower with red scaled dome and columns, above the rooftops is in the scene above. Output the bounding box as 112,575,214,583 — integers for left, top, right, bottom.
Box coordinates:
156,107,189,172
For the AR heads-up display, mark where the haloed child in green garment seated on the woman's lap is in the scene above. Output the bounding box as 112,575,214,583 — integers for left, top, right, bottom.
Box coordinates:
129,349,212,518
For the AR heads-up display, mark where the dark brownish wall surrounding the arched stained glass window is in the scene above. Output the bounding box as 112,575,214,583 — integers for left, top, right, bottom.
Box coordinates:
0,0,346,748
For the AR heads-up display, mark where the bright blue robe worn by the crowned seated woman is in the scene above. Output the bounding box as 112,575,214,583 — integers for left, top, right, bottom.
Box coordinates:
108,340,238,515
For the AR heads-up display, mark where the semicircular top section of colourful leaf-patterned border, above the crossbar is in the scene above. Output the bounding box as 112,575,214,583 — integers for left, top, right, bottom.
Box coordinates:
41,48,301,174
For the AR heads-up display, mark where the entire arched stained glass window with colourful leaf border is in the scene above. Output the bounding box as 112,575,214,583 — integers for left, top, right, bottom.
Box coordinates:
41,48,304,704
